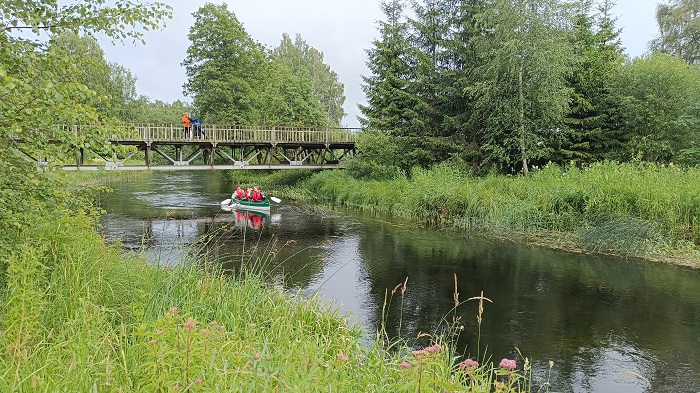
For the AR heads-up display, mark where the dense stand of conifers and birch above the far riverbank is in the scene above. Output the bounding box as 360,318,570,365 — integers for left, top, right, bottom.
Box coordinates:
360,0,700,174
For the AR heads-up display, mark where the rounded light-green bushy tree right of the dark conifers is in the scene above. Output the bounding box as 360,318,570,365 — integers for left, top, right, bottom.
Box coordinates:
616,54,700,162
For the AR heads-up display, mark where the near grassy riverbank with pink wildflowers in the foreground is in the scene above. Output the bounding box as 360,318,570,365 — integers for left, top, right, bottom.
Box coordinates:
0,208,531,392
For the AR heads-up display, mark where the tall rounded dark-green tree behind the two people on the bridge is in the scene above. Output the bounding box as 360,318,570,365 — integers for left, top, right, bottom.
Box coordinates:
183,3,270,124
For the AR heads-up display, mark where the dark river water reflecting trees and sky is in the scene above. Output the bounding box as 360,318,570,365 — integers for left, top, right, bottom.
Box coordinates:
100,171,700,393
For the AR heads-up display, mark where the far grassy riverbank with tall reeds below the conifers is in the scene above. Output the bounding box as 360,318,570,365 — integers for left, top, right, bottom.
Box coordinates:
234,163,700,267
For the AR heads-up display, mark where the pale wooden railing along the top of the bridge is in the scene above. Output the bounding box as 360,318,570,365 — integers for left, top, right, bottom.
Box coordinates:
124,124,360,144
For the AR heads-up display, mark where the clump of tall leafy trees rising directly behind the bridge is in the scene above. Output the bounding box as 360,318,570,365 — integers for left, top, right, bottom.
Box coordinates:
183,3,345,126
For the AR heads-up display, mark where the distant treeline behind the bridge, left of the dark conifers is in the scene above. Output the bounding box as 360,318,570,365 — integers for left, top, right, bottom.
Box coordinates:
49,4,345,127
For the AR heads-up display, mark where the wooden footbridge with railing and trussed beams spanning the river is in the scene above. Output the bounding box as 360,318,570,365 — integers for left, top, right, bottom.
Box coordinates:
45,124,360,170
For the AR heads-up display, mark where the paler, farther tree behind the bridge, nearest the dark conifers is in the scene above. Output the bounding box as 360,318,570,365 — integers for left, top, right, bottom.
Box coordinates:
272,33,346,127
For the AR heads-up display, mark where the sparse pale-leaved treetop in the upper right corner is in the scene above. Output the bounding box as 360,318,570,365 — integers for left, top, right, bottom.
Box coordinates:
649,0,700,64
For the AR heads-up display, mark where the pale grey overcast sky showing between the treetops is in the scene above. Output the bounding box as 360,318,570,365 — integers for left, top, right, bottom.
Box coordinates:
101,0,659,127
